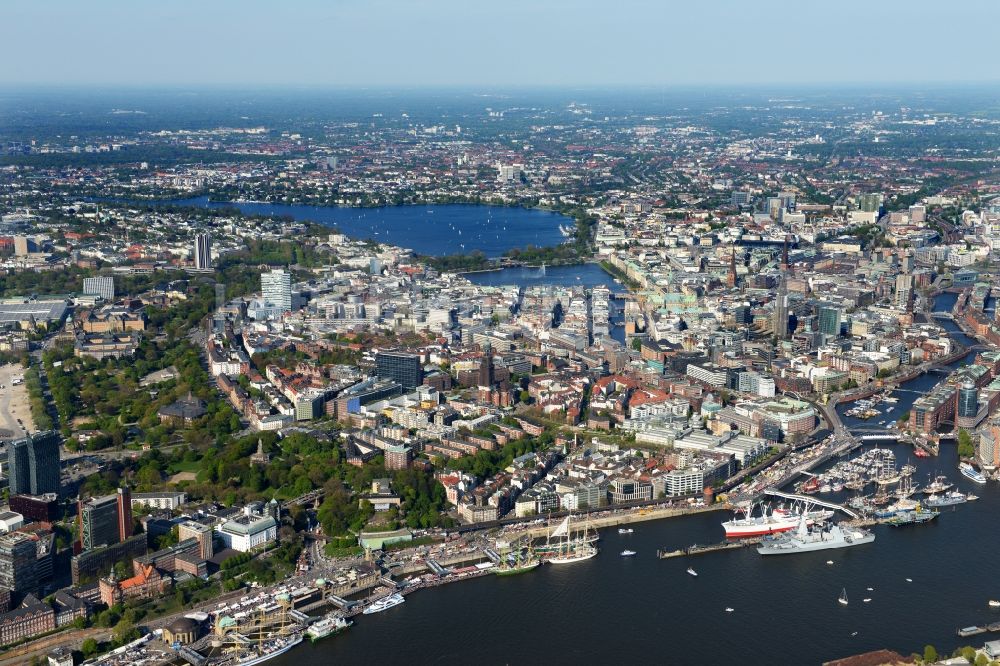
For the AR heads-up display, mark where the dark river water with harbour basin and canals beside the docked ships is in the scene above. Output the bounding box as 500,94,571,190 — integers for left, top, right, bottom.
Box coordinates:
272,295,1000,666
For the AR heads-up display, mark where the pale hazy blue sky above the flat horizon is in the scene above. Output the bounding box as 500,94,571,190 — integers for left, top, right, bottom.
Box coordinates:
7,0,1000,86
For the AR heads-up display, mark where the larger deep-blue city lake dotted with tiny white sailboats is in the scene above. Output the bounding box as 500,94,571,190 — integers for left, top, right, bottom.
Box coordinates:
169,197,576,257
